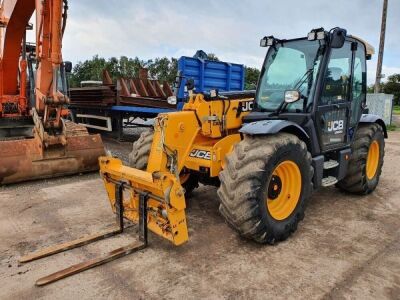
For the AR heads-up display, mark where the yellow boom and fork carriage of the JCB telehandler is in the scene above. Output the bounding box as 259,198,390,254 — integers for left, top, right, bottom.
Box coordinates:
99,94,253,245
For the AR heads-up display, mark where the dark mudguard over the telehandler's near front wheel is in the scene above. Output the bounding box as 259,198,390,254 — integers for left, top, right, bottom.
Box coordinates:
239,120,310,140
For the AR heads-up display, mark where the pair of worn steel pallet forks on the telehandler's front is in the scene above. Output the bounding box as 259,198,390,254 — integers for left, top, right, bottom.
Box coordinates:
19,182,149,286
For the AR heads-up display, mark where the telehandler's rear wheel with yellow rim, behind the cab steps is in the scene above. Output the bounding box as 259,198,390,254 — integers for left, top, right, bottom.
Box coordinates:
337,123,385,195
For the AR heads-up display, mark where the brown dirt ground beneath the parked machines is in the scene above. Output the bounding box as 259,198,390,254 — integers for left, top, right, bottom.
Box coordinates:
0,132,400,299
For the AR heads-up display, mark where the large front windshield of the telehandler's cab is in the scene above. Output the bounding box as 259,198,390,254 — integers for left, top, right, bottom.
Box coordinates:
256,39,323,112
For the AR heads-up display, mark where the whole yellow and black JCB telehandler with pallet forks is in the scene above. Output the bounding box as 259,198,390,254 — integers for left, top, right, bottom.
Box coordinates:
21,28,387,285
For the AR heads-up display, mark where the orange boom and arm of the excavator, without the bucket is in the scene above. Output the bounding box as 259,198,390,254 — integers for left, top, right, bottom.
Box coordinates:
0,0,69,129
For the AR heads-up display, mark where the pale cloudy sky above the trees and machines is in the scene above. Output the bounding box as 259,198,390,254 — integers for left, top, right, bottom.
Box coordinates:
41,0,400,84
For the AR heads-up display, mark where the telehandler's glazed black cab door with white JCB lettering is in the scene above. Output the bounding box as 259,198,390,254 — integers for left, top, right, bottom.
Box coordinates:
316,41,355,152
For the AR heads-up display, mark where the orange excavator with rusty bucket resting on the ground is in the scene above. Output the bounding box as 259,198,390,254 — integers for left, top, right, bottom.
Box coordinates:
0,0,104,185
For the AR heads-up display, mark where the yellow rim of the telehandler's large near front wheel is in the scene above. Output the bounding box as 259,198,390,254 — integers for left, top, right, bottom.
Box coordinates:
266,160,302,221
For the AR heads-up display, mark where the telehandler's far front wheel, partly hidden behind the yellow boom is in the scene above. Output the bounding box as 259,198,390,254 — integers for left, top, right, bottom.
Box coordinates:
129,129,199,197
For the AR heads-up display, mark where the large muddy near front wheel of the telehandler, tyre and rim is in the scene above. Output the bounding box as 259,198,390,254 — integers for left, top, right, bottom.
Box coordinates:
218,133,313,244
